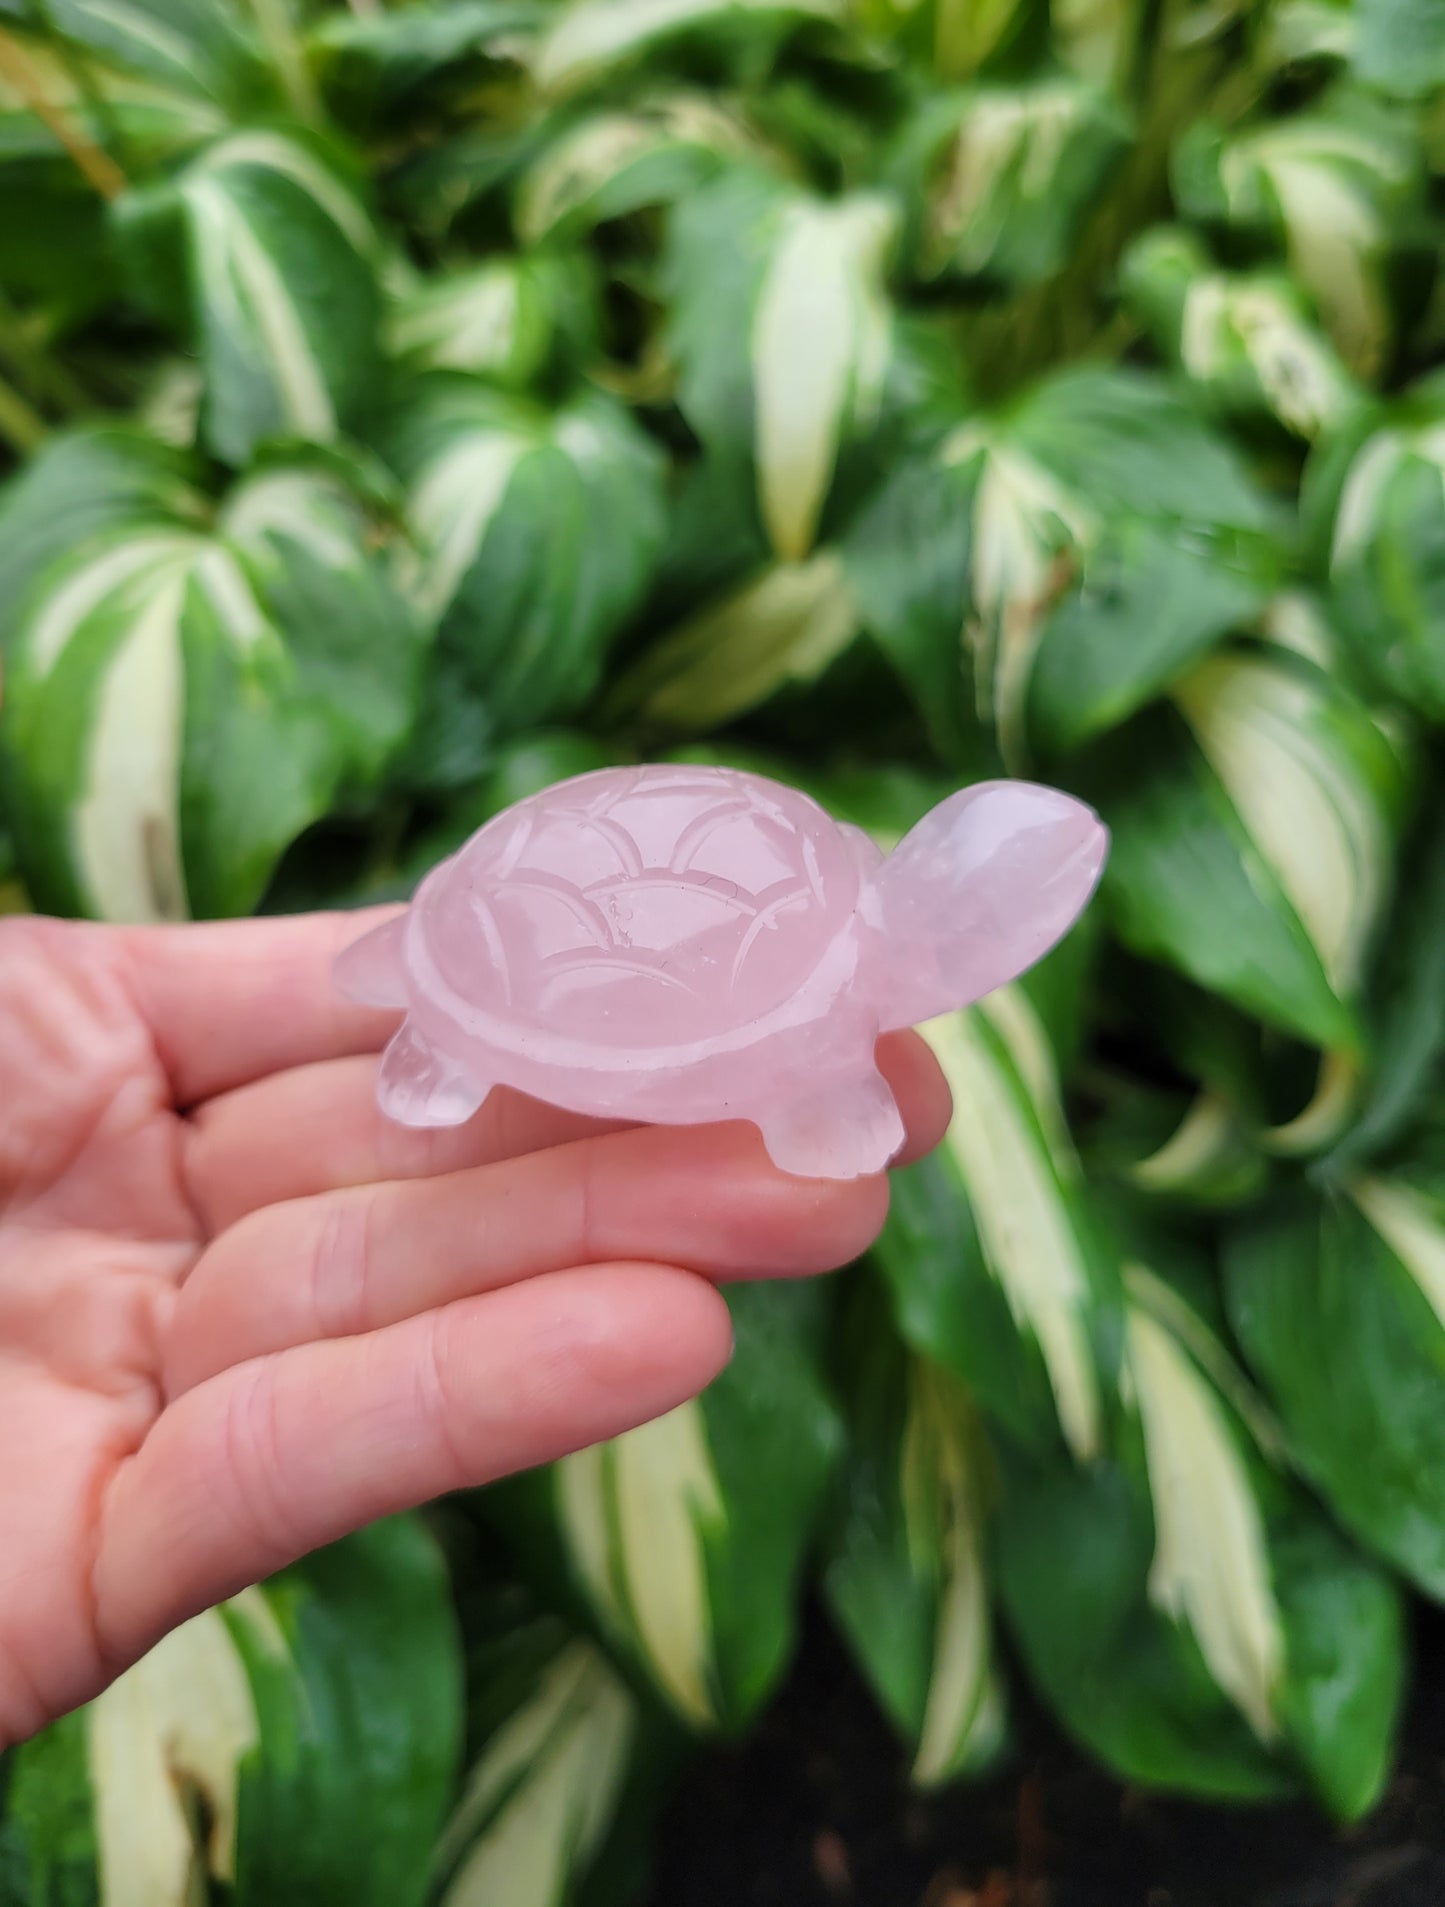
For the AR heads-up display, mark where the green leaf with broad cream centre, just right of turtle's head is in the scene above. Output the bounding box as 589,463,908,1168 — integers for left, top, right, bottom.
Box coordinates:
1090,650,1409,1051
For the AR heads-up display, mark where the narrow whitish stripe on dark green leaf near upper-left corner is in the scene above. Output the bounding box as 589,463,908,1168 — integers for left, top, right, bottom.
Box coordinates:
185,175,337,442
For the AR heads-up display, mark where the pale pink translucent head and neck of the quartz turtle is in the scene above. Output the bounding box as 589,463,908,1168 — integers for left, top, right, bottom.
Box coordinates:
860,782,1108,1030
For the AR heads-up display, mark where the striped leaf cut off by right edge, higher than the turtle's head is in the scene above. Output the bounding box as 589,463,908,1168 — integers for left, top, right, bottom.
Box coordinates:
1304,378,1445,721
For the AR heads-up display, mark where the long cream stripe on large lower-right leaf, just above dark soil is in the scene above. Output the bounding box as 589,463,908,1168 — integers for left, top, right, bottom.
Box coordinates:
1127,1281,1285,1745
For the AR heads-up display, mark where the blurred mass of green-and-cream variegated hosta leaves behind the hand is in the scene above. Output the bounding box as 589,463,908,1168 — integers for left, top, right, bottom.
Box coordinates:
0,0,1445,1907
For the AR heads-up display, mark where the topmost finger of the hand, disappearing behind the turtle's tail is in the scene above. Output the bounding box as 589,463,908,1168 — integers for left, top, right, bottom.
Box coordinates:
112,908,397,1106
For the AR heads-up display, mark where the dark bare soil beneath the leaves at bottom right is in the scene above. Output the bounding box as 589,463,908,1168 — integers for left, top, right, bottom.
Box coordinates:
648,1615,1445,1907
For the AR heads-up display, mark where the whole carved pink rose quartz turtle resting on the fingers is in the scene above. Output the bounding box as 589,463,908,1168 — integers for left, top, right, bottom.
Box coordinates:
337,767,1108,1179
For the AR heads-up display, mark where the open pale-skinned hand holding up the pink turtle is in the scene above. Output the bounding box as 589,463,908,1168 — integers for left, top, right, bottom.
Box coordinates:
0,913,949,1749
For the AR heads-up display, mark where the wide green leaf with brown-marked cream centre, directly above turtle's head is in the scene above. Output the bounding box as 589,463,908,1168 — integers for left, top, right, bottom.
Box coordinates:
843,368,1281,774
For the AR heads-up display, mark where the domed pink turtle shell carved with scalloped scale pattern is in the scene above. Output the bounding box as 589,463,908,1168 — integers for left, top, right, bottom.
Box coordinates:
414,767,862,1049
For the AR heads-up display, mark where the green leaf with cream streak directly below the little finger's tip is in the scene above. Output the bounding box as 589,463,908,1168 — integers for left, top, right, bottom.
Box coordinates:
494,1283,841,1732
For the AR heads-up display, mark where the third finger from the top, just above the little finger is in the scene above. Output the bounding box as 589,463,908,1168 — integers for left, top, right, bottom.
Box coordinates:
166,1123,888,1396
